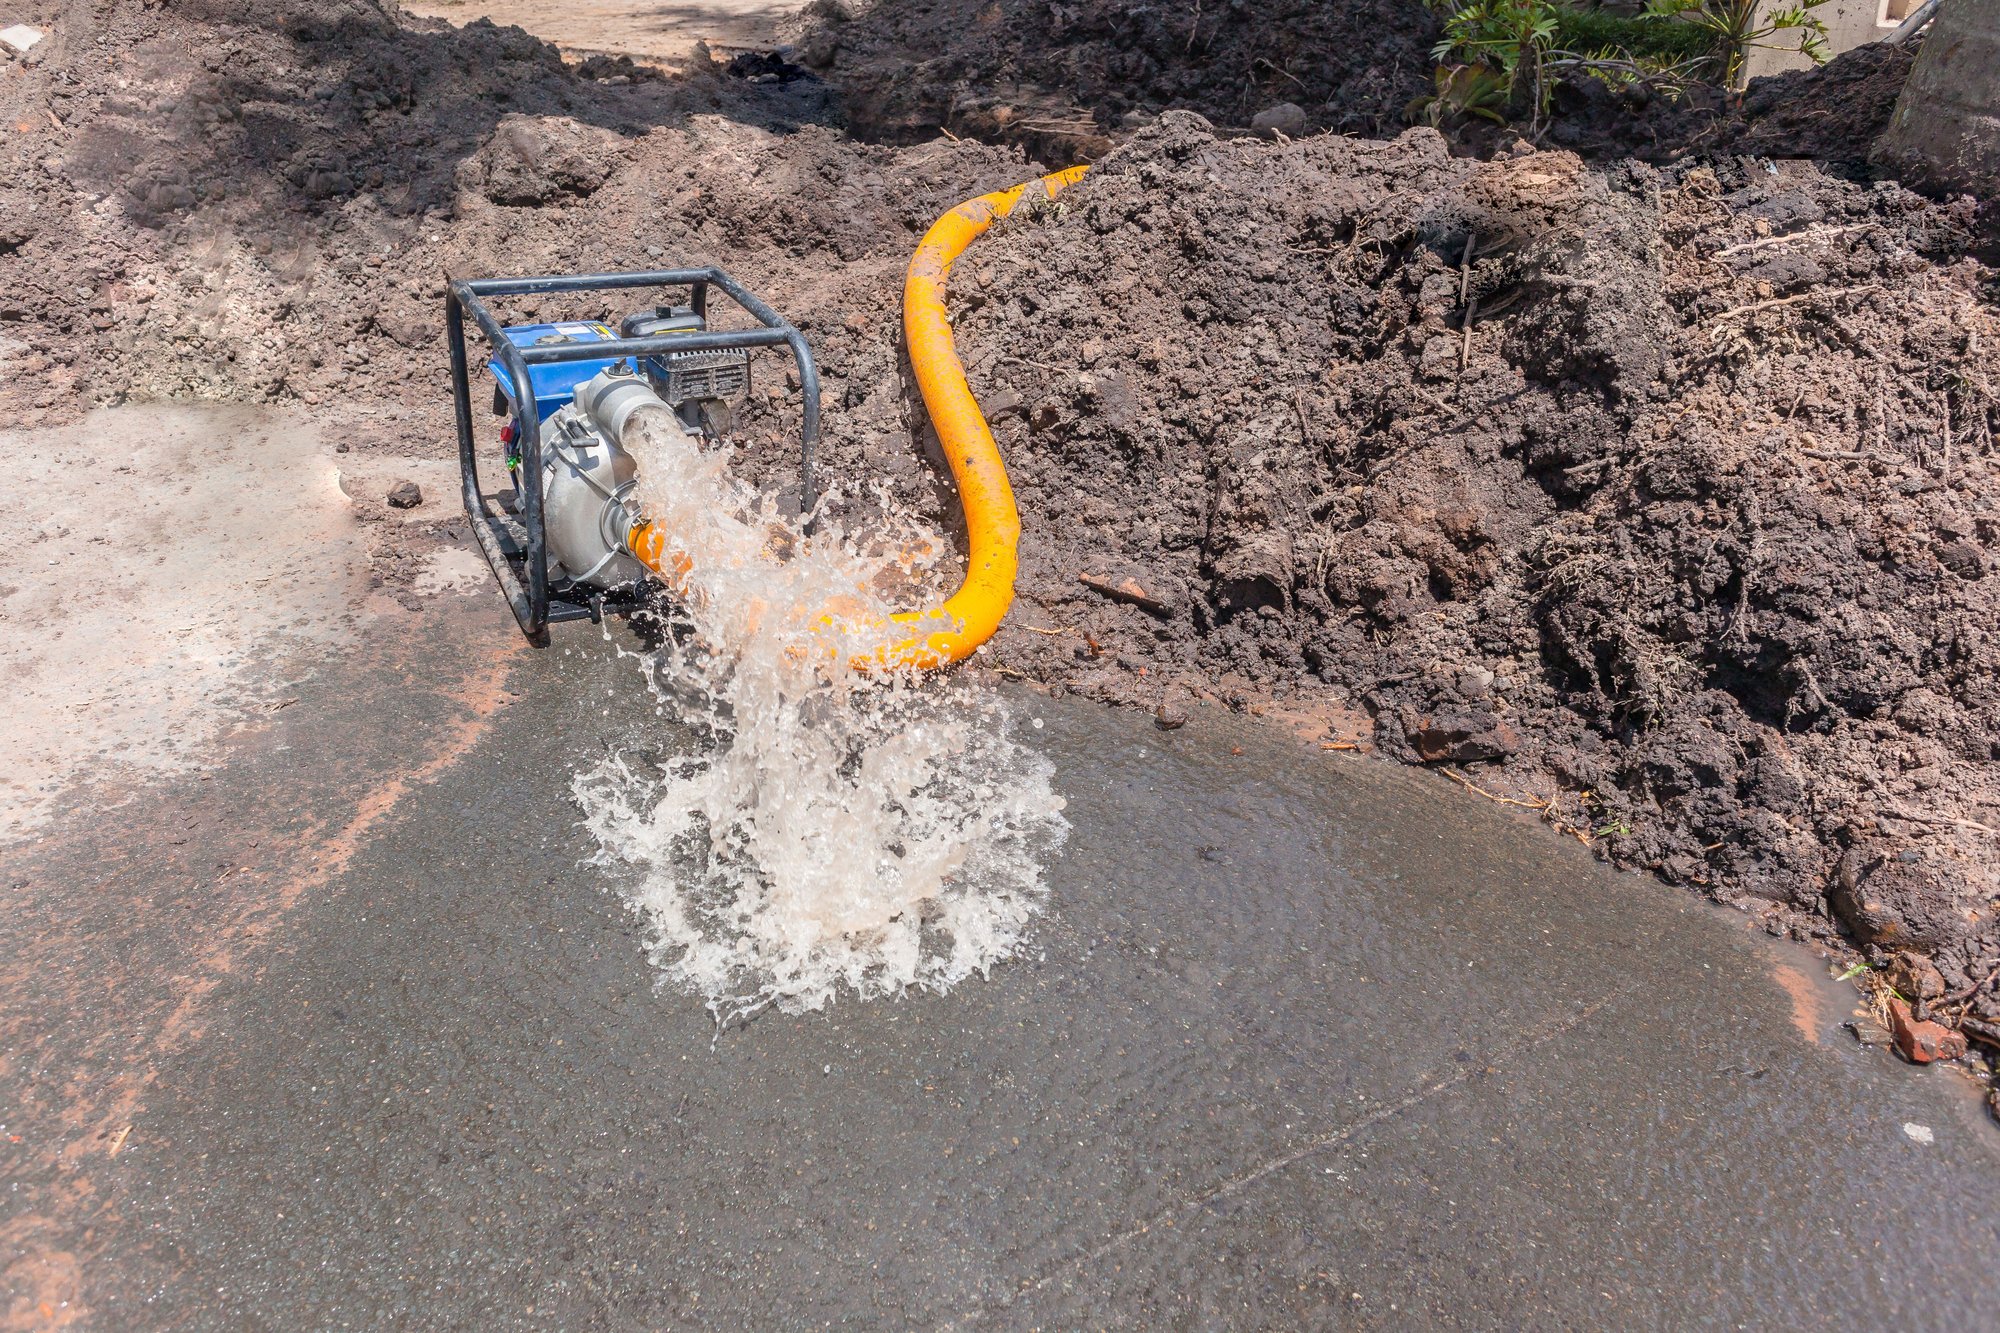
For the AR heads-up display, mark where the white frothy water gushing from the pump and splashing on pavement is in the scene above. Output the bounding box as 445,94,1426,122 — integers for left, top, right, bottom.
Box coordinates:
574,402,1068,1027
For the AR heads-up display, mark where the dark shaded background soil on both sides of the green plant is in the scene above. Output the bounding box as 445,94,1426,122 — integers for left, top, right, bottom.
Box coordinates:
798,0,1916,195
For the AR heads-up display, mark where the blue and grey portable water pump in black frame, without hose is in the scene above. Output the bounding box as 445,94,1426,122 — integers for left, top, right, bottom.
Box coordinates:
444,268,820,644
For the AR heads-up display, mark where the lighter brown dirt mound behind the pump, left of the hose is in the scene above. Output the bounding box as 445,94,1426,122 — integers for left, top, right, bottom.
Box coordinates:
0,0,1026,422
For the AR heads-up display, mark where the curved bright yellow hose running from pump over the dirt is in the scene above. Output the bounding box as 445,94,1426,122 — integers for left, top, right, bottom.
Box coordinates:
628,166,1090,671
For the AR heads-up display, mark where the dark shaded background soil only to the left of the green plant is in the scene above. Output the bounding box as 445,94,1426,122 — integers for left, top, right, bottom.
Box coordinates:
798,0,1438,156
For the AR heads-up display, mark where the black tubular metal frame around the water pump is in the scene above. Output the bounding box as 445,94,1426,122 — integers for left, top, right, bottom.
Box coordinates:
444,268,820,644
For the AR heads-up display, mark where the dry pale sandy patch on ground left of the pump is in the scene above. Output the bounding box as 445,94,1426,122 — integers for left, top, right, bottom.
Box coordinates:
0,404,368,843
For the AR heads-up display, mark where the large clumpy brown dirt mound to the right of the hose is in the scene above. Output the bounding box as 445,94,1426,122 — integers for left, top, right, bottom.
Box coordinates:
796,112,2000,1017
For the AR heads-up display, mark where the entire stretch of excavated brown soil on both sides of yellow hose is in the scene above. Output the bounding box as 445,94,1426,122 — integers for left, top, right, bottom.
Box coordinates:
11,0,2000,1039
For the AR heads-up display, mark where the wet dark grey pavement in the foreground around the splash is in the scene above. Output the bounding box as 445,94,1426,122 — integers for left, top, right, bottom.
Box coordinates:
0,598,2000,1329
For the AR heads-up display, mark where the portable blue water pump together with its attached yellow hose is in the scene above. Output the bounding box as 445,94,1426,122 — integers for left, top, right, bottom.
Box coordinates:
444,166,1088,673
